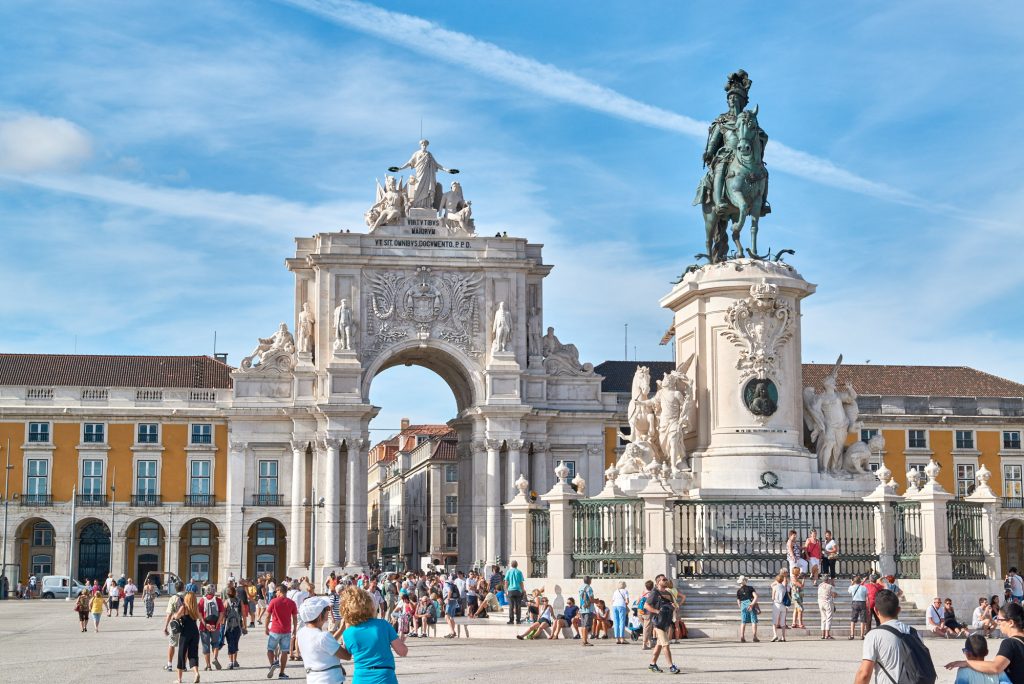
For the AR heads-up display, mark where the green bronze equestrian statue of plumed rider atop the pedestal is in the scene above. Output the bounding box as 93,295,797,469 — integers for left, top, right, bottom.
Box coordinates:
693,70,771,263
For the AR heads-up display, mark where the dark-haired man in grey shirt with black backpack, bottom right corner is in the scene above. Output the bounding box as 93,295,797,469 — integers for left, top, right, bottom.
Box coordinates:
854,589,937,684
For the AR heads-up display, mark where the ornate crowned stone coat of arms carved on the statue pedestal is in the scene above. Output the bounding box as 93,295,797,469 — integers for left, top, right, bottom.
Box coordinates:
722,280,794,382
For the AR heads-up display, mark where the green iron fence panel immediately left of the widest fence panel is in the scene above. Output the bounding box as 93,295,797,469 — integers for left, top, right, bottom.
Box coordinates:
572,499,644,578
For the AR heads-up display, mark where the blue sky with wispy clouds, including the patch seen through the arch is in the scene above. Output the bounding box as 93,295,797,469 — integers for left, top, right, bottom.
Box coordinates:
0,0,1024,430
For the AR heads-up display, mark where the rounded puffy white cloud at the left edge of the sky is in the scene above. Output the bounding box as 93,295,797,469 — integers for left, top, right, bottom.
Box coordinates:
0,115,92,173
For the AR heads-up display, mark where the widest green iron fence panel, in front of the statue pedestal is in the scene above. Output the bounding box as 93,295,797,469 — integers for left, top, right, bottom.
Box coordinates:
673,501,879,578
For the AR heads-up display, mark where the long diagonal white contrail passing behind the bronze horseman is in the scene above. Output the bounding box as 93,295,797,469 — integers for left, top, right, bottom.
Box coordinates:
282,0,927,207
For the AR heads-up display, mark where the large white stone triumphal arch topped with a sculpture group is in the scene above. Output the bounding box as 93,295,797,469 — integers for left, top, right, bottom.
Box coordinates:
229,141,614,573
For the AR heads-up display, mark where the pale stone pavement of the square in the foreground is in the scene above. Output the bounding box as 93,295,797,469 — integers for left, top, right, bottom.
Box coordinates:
0,600,974,684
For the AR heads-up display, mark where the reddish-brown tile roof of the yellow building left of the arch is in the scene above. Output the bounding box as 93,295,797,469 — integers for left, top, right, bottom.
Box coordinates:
0,354,233,389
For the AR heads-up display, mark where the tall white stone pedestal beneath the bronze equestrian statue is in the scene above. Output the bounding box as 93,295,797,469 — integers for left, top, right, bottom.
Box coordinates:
660,259,820,494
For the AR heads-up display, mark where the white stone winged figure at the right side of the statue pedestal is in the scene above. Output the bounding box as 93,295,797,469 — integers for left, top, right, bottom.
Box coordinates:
804,354,869,474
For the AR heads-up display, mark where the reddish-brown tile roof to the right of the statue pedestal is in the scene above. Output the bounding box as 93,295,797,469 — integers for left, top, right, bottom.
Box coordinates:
804,364,1024,397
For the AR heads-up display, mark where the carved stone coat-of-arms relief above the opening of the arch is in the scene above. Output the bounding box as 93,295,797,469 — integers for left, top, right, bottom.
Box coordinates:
364,266,483,357
